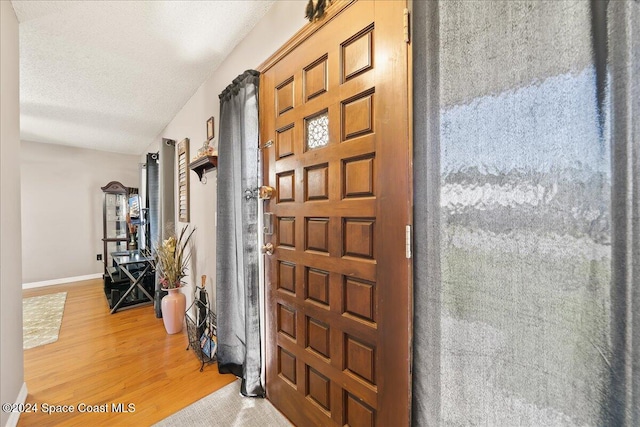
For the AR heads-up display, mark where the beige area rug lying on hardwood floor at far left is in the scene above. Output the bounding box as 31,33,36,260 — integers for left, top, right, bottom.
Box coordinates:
22,292,67,350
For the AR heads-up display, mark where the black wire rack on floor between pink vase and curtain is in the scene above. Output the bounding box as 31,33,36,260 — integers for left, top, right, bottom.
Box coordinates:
185,276,218,372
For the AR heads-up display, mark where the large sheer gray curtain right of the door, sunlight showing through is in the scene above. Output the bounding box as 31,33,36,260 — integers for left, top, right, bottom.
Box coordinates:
413,0,640,427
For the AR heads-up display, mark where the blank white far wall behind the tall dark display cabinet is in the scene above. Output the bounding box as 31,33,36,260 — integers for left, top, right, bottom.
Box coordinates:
21,142,140,283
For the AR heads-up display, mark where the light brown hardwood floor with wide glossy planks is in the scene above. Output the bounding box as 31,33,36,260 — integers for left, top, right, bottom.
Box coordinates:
18,279,235,426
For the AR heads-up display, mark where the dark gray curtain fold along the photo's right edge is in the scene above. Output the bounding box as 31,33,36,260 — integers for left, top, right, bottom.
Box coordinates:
606,1,640,426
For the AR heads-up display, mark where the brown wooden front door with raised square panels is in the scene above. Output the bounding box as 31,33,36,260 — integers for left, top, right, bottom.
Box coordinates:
260,0,412,427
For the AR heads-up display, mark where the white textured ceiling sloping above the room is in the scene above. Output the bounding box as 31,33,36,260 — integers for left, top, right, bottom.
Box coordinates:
12,0,273,154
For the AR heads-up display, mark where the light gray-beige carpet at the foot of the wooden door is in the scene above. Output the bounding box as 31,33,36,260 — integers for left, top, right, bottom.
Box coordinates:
154,380,292,427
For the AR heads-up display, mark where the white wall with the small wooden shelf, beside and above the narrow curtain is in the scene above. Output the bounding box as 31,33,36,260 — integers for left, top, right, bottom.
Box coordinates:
147,1,306,306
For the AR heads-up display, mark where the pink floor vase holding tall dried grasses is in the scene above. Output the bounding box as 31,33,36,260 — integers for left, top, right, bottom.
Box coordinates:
154,226,195,334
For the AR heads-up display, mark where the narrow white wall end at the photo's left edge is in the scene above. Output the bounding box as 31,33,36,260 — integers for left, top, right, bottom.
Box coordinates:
0,1,26,426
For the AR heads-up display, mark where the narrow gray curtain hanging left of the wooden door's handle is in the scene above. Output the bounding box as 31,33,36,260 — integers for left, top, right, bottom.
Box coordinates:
216,70,264,397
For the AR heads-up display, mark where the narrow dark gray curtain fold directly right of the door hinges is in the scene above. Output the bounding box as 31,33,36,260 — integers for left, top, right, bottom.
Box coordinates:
411,1,440,427
